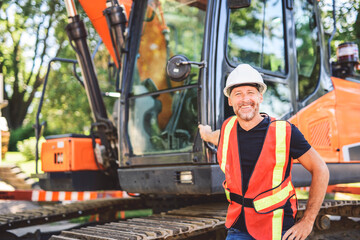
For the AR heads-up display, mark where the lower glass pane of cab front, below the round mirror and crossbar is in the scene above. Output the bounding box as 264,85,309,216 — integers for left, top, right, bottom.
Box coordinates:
128,87,197,155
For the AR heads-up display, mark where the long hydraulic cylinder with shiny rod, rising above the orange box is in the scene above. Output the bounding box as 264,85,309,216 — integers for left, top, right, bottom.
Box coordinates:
65,0,118,170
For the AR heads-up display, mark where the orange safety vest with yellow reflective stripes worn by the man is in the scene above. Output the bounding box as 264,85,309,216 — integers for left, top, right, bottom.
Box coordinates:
217,116,297,239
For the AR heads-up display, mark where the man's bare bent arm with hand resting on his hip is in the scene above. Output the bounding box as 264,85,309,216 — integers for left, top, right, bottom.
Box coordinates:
282,148,329,240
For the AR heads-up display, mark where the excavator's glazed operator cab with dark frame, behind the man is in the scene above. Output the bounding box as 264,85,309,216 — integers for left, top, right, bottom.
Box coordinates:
118,1,294,194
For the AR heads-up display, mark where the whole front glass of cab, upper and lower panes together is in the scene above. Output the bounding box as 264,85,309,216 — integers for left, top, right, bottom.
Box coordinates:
128,0,206,155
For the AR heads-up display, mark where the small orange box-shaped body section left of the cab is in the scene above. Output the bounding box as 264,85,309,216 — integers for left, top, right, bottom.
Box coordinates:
41,137,100,172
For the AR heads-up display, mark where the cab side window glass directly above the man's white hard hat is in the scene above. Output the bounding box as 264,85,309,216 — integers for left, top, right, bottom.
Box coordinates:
227,0,286,74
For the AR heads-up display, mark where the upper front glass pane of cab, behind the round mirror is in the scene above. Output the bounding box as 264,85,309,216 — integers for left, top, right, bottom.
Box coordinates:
132,0,206,94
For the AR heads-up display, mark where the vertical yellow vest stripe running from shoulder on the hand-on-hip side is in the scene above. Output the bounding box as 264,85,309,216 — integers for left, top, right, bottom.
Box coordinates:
272,121,286,188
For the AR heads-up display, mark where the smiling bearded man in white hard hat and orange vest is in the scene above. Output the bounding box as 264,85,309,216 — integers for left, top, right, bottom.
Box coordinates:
199,64,329,240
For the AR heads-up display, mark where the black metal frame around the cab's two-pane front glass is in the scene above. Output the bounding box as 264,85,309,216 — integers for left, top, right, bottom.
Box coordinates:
119,1,216,167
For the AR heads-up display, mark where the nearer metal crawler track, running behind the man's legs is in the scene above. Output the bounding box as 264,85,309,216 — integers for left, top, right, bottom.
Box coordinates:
50,200,360,240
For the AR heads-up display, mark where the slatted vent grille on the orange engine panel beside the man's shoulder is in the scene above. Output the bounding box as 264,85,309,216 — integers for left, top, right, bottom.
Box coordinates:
309,119,331,149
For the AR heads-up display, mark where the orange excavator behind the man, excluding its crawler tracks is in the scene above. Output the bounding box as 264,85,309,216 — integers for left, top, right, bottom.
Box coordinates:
36,0,360,195
